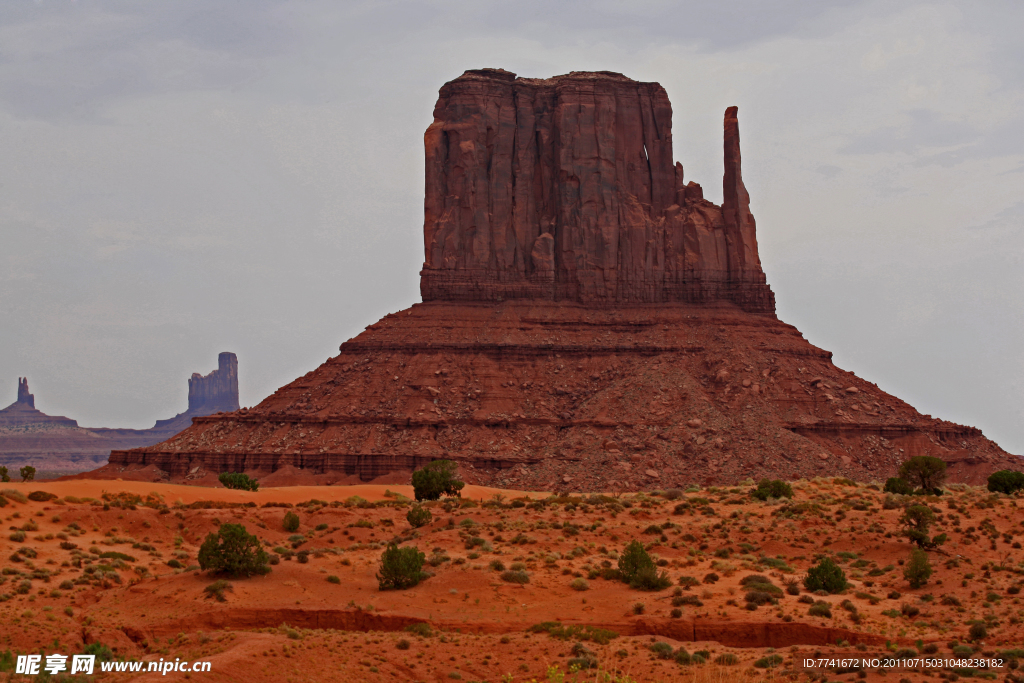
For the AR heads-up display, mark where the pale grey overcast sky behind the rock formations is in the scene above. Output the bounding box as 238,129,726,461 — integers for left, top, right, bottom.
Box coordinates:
0,0,1024,454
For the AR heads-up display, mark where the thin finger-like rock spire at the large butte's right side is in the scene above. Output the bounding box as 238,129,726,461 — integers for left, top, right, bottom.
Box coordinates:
722,106,764,281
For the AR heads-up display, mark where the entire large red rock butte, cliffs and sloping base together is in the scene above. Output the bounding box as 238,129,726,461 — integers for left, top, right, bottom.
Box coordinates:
103,69,1020,490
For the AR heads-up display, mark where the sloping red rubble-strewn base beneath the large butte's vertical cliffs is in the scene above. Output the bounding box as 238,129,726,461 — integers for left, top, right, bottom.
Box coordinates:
111,301,1018,490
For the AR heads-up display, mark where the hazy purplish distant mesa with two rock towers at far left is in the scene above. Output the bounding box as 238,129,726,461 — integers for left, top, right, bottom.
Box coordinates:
0,352,239,479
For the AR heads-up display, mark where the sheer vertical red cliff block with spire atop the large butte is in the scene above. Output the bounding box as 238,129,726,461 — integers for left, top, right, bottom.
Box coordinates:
420,69,775,314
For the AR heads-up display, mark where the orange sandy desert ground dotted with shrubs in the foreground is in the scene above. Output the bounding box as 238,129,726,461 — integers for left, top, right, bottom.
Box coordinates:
0,479,1024,683
